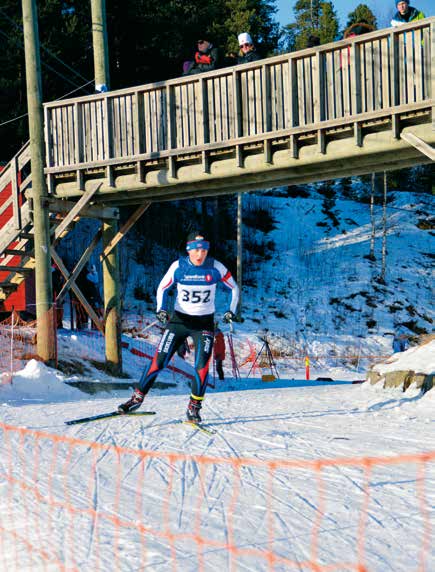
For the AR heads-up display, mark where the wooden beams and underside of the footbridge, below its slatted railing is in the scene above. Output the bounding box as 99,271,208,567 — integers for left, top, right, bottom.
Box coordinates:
47,113,435,205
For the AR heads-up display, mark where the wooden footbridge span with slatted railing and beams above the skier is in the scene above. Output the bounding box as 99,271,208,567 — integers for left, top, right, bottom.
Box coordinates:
39,18,435,205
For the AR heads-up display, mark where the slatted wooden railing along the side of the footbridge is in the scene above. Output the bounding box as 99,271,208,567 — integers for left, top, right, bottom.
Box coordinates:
45,18,435,172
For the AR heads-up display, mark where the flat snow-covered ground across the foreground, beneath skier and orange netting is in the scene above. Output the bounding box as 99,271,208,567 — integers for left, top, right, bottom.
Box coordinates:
0,334,435,572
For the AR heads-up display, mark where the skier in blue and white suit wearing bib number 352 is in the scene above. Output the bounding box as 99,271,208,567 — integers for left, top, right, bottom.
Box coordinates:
118,232,239,423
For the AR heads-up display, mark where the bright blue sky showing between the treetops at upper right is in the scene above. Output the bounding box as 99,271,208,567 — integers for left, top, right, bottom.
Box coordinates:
276,0,434,27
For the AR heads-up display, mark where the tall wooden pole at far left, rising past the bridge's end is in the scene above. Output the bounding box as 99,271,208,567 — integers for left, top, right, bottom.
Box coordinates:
22,0,55,363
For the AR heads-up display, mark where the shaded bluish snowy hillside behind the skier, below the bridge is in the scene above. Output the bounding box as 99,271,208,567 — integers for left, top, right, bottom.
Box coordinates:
90,181,435,368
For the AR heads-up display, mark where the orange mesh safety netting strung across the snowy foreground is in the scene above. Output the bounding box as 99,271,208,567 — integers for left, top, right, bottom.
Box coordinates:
0,423,435,572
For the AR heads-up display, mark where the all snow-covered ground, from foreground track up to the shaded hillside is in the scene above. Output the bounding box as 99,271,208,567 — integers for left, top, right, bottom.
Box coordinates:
0,188,435,572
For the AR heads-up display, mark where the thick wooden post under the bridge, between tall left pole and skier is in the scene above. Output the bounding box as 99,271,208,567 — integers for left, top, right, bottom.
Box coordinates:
103,220,122,375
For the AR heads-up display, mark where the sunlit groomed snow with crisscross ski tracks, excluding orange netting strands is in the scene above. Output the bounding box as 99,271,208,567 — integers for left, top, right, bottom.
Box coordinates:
0,378,435,572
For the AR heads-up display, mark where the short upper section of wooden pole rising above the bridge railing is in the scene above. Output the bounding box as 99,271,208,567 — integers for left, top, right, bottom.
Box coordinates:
91,0,110,92
